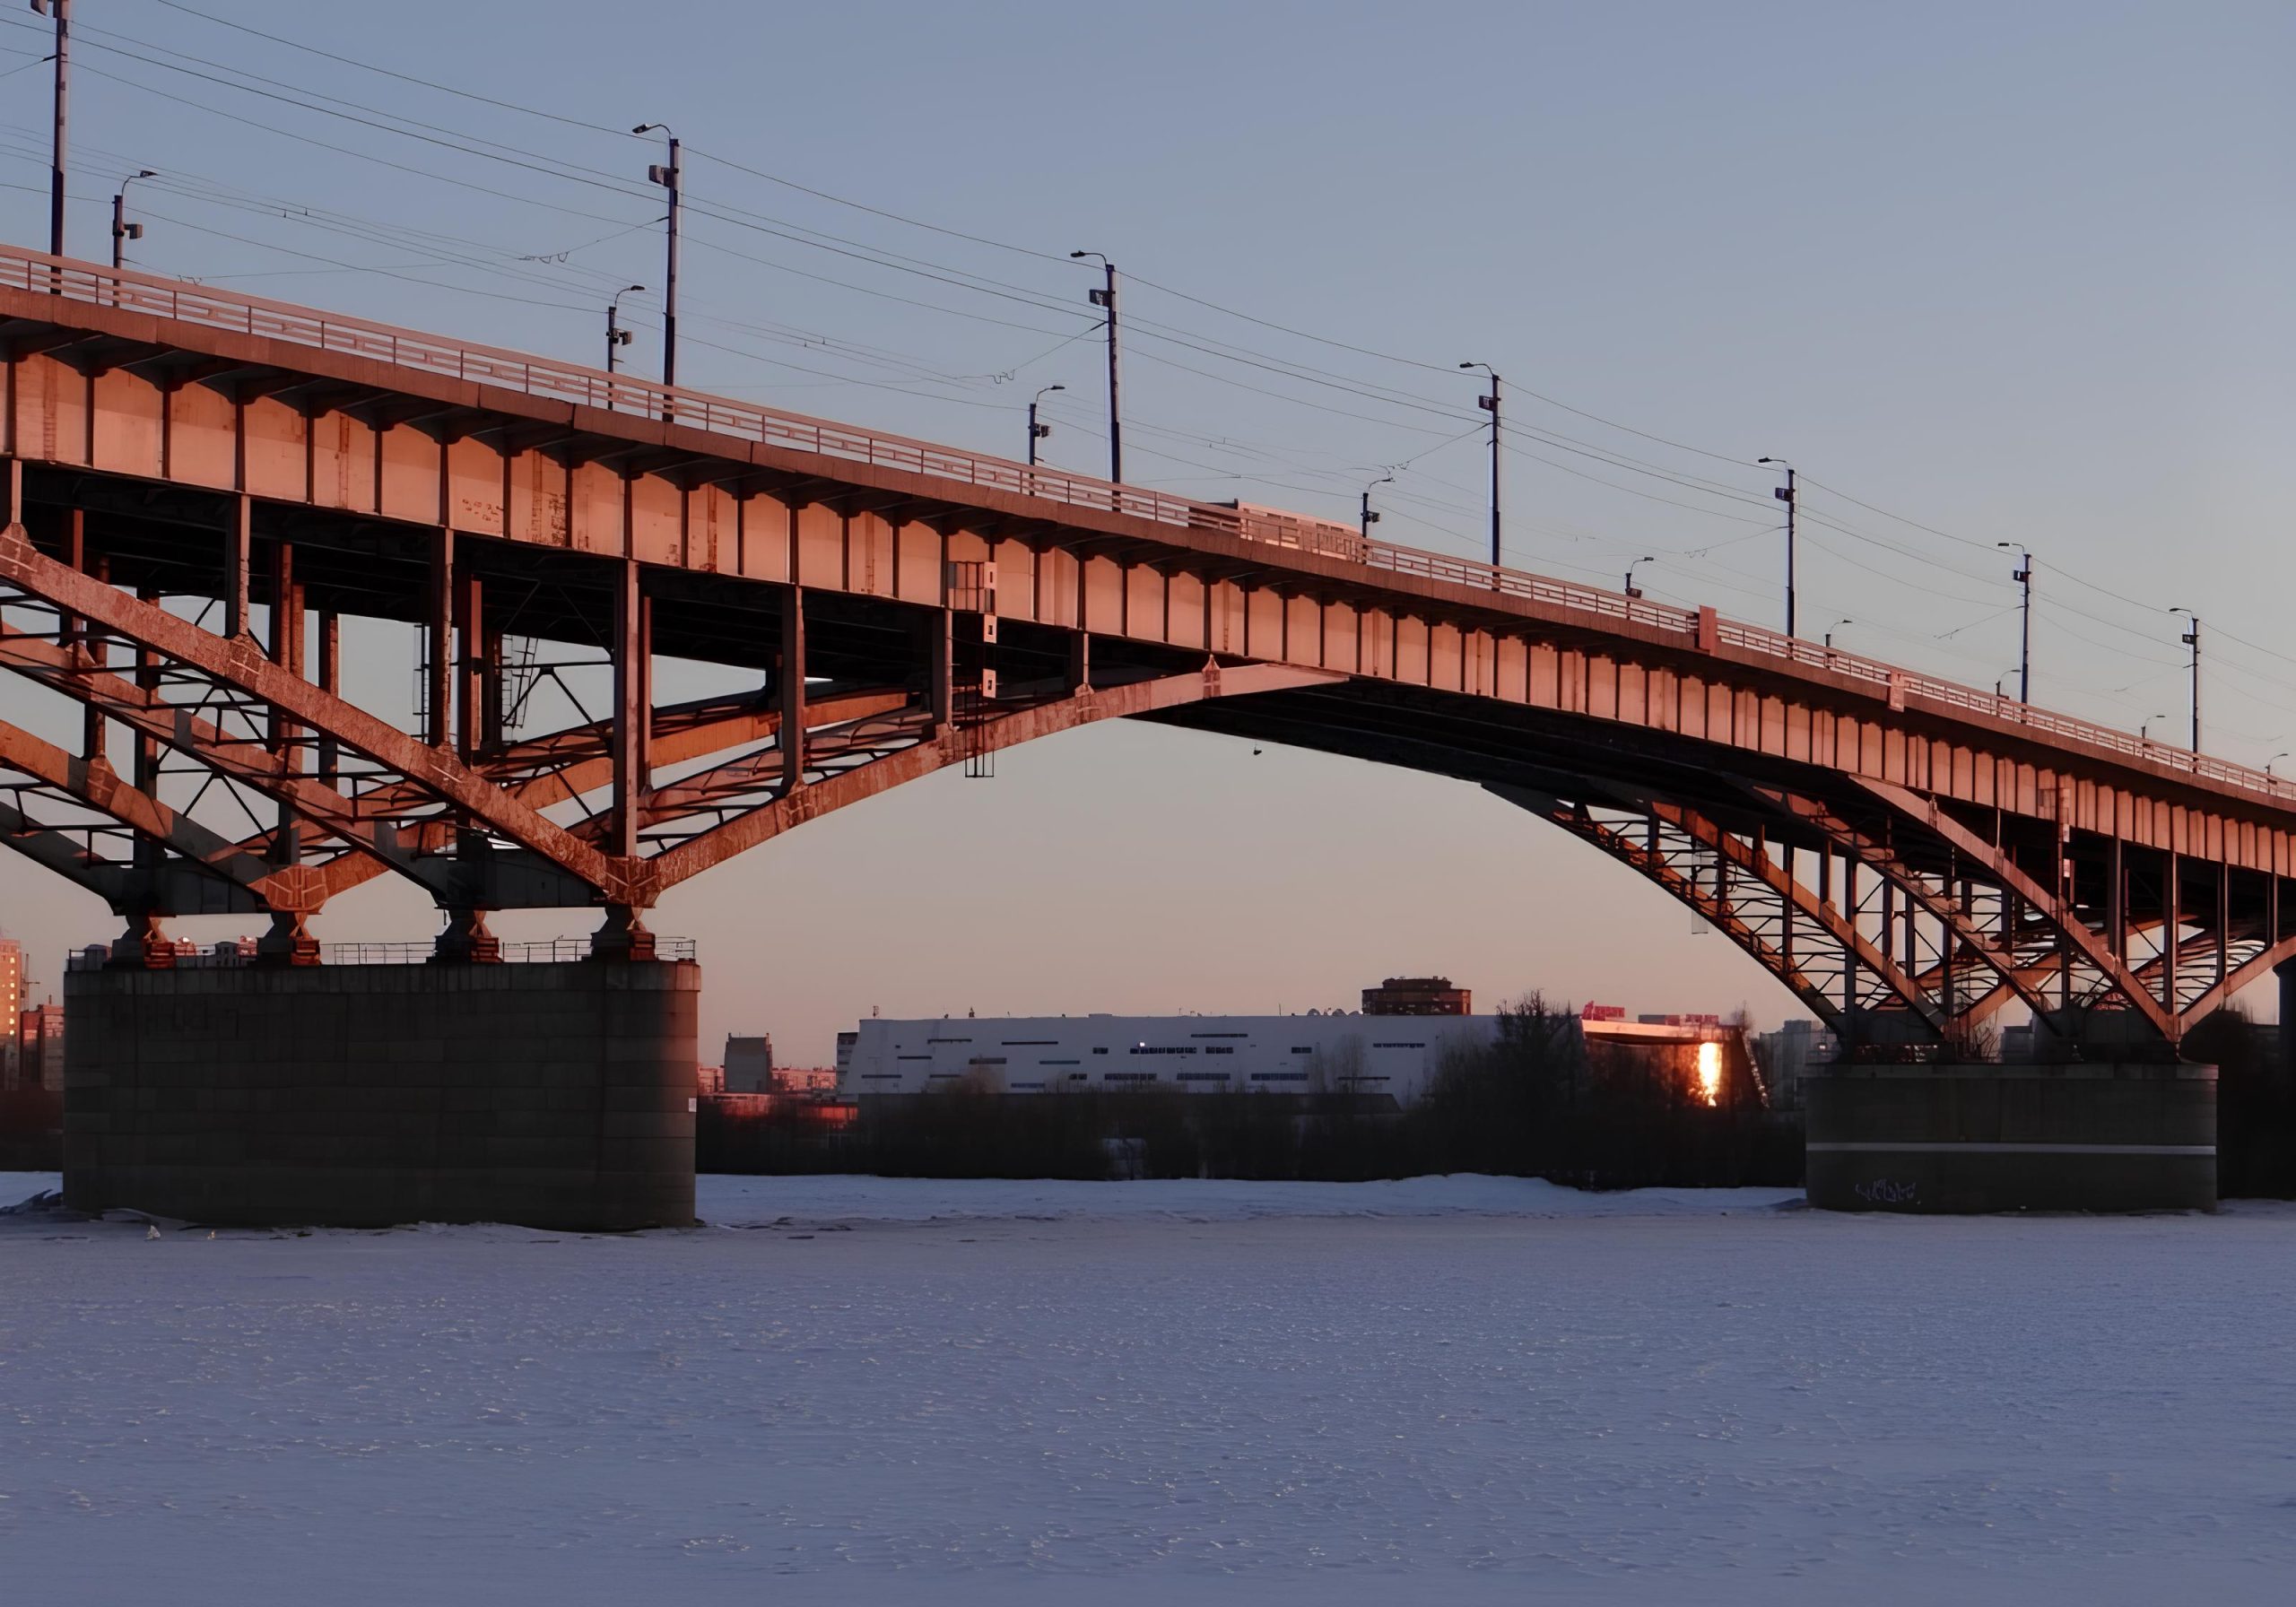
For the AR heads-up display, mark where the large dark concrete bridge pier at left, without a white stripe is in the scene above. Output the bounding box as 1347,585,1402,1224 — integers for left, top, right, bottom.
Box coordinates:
65,958,700,1230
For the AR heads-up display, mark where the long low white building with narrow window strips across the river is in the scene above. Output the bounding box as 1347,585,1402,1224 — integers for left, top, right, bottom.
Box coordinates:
838,1012,1500,1104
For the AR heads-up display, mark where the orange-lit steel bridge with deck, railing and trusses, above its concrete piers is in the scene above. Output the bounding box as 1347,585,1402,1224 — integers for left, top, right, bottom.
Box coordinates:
0,250,2296,1045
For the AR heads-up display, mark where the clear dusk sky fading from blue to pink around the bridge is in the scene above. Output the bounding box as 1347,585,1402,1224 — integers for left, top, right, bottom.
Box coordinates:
0,0,2296,1063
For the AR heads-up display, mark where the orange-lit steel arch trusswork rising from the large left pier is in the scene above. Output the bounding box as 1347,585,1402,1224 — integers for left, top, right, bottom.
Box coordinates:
0,526,1332,943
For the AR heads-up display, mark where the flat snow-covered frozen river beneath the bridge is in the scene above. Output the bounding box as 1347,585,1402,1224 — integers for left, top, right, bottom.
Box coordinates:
0,1176,2296,1607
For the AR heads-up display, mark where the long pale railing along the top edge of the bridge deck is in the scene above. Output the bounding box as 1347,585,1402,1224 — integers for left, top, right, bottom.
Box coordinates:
0,246,2296,799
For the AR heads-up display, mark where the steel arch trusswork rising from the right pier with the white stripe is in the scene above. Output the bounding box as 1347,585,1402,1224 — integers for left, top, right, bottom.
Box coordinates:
1495,783,2296,1040
